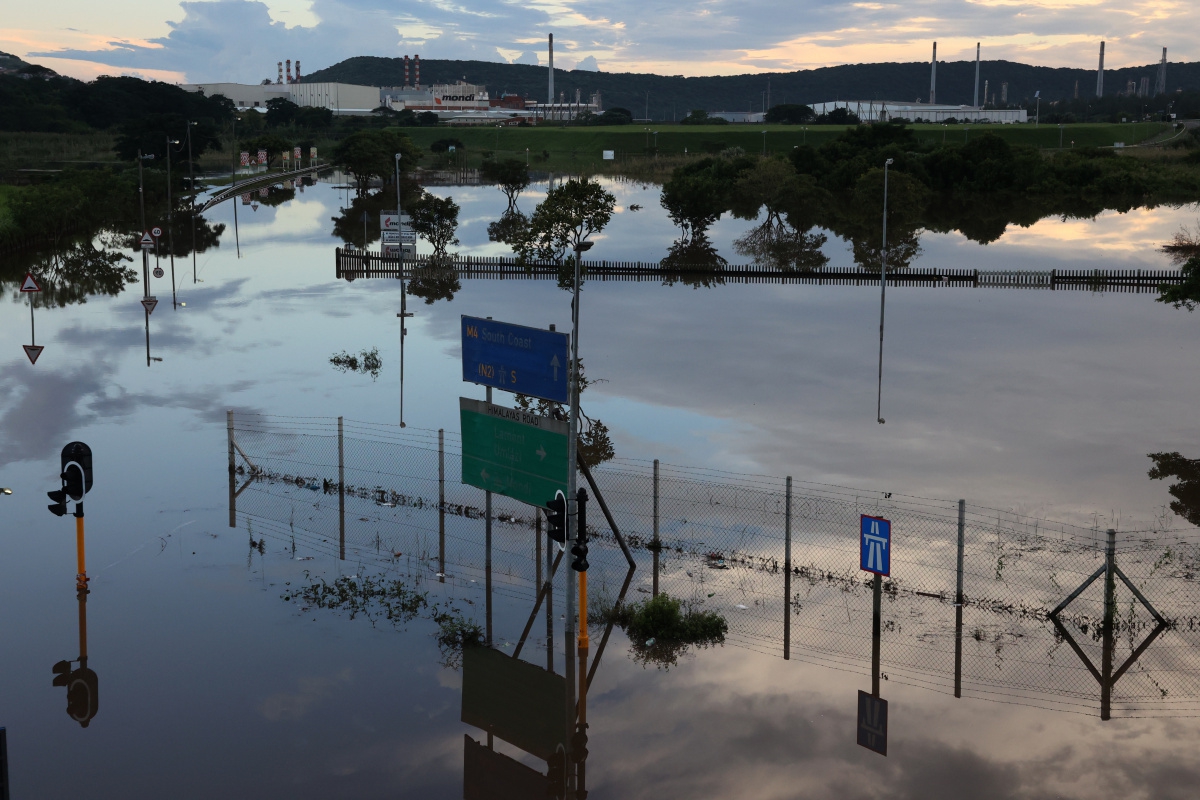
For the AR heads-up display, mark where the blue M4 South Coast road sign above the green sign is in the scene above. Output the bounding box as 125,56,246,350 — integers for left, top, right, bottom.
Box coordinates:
462,317,570,403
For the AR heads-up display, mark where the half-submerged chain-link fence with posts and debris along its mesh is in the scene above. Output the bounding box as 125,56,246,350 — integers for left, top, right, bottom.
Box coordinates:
229,414,1200,716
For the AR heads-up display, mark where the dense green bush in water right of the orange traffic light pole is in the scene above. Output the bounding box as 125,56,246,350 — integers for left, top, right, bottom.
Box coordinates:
592,594,728,669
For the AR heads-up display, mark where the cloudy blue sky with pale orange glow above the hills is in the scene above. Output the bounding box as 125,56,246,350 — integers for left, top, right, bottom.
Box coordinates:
0,0,1200,83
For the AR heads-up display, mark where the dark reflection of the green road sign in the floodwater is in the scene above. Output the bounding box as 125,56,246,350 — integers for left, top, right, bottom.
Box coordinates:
462,645,566,760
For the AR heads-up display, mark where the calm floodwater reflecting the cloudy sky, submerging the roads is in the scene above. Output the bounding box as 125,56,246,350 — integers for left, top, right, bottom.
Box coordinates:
0,184,1200,799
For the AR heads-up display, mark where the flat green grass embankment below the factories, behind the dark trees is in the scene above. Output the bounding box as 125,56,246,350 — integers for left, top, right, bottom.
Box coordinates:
404,122,1170,172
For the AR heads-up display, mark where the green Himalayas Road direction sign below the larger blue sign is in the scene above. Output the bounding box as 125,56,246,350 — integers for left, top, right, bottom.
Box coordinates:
458,397,569,506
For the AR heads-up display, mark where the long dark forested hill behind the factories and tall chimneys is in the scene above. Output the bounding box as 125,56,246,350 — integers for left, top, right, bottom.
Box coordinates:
304,56,1200,120
